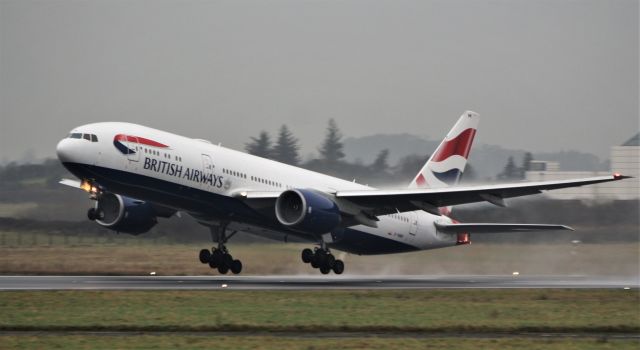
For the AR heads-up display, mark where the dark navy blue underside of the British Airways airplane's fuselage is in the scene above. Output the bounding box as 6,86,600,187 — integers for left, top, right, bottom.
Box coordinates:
64,163,450,255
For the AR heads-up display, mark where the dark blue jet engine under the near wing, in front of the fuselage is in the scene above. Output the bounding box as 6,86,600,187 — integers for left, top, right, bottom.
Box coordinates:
276,189,342,234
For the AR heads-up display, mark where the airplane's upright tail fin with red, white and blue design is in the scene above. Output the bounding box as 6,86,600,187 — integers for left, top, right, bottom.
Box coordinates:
409,111,480,188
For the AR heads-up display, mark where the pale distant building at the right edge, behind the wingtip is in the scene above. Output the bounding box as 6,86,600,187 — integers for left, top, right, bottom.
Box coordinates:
525,133,640,200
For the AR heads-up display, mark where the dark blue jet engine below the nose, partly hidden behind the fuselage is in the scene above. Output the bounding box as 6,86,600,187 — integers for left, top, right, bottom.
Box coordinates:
96,192,158,235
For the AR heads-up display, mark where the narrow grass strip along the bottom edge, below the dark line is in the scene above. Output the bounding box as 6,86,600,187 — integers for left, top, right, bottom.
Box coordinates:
0,335,638,350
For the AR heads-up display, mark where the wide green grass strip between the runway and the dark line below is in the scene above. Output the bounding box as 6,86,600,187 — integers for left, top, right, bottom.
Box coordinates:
0,289,640,333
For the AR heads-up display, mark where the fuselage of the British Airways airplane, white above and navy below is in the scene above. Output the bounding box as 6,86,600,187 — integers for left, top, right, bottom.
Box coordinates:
58,122,458,254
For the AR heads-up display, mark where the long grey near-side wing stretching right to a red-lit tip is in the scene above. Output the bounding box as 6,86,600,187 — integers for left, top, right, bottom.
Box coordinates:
335,174,630,215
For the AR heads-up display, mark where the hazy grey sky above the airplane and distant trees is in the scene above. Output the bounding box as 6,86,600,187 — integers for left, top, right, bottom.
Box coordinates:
0,0,640,161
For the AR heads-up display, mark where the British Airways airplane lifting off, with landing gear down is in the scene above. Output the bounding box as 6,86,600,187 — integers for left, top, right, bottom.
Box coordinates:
56,111,629,274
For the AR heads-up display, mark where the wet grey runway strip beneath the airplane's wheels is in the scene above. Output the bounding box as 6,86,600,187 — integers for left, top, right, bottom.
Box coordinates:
0,275,640,291
